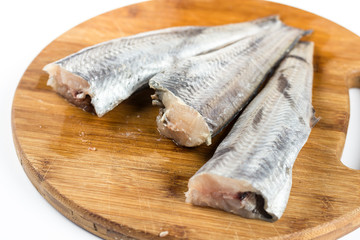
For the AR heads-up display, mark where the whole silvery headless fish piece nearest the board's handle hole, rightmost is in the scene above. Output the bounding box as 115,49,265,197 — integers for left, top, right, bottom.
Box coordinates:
186,42,318,221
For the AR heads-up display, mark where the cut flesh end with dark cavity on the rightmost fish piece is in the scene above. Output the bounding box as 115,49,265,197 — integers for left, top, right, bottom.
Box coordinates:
185,173,278,222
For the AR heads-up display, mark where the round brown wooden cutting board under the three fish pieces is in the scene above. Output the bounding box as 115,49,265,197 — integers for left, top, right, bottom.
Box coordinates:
12,0,360,239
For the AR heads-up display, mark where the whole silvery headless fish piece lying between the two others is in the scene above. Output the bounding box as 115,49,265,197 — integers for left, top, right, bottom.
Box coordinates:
149,23,308,147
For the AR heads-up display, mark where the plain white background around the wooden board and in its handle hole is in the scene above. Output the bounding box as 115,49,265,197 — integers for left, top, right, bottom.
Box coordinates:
0,0,360,240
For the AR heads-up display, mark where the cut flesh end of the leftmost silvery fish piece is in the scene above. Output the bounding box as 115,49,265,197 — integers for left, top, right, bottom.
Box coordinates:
43,63,95,113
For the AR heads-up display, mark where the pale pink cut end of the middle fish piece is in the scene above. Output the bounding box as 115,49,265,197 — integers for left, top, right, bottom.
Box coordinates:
152,91,211,147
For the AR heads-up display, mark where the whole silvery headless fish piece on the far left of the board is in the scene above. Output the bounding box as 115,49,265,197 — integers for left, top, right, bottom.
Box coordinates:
44,16,279,117
